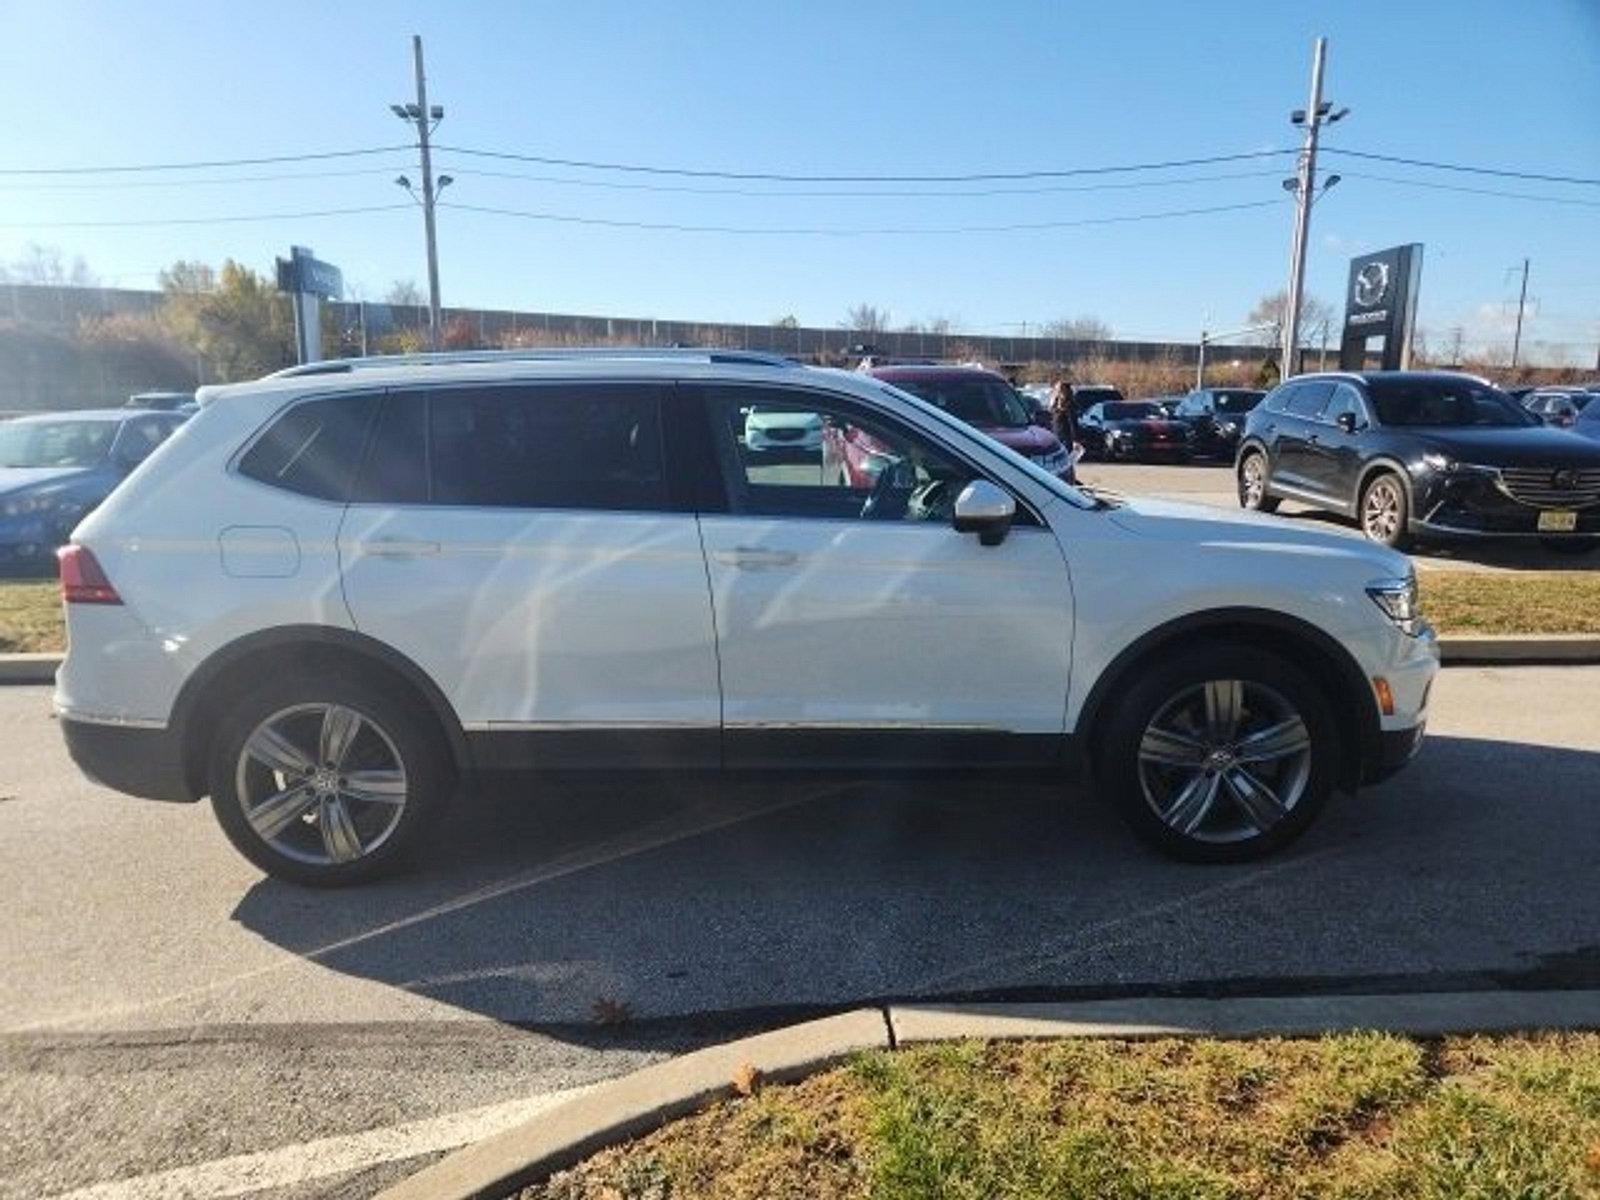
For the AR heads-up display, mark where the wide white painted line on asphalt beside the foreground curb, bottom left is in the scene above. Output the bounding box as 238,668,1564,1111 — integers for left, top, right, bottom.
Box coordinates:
46,1086,589,1200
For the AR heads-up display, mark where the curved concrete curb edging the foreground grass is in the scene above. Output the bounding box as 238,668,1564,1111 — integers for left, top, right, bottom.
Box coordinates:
378,990,1600,1200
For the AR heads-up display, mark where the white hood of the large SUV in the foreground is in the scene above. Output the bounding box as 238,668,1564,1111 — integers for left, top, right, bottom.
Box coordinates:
1109,499,1411,579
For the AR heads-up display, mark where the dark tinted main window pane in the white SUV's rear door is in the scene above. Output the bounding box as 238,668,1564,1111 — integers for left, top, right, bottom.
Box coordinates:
427,384,667,509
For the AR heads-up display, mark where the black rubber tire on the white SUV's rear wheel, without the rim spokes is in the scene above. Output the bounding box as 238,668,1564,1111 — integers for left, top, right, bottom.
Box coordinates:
208,674,454,888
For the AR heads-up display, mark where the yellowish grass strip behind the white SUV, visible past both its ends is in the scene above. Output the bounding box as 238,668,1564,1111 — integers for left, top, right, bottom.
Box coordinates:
0,571,1600,653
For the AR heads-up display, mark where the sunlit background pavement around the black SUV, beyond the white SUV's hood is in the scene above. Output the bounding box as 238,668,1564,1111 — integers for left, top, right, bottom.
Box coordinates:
1078,462,1600,571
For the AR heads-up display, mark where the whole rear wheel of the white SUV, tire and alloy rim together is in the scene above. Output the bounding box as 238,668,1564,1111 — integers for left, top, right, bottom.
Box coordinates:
210,675,451,886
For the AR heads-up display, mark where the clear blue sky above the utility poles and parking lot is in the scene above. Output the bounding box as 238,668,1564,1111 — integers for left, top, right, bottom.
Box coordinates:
0,0,1600,363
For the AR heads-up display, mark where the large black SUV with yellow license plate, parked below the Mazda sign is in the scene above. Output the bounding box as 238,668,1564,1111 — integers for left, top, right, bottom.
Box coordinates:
1235,371,1600,552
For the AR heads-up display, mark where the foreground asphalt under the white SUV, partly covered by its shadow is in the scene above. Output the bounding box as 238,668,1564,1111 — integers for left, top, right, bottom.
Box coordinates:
0,667,1600,1200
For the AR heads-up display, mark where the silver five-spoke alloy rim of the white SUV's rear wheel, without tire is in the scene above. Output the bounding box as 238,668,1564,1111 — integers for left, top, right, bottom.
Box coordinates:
235,704,410,867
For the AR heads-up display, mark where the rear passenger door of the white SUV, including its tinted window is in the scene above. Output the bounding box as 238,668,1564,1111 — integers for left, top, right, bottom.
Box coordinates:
339,382,720,766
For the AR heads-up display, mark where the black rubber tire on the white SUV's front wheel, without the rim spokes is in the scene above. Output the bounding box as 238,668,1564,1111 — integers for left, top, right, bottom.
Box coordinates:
1094,643,1344,862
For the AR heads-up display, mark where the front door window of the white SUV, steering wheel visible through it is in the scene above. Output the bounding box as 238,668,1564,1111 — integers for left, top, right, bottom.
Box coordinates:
706,387,978,522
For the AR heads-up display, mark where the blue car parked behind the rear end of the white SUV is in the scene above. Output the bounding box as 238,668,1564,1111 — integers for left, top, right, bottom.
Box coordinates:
0,408,189,574
